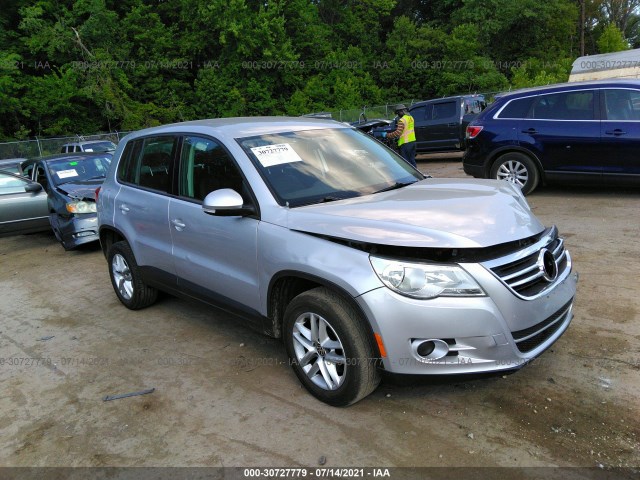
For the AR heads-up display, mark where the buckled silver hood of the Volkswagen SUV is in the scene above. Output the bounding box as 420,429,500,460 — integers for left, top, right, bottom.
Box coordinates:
287,178,544,248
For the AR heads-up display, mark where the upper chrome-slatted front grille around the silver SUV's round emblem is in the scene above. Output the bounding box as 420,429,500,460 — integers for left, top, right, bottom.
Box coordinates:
487,228,571,298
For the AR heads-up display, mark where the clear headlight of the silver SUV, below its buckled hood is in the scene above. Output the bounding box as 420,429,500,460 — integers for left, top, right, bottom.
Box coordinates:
370,256,485,299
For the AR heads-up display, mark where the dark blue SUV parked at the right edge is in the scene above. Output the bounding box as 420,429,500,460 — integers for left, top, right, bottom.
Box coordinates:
463,80,640,194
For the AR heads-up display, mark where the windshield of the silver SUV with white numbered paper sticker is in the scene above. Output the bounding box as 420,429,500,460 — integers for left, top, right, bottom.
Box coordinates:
238,128,424,207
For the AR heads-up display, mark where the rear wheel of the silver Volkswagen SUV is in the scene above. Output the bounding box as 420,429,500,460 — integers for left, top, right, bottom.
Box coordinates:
107,241,158,310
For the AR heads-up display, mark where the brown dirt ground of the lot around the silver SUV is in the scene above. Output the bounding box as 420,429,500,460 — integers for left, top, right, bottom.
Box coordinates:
0,155,640,468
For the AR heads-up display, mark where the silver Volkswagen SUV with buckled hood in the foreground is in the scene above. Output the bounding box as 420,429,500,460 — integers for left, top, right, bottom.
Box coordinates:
98,118,577,405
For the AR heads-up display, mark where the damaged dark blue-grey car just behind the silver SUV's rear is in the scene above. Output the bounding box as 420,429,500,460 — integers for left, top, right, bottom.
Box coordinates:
21,153,113,250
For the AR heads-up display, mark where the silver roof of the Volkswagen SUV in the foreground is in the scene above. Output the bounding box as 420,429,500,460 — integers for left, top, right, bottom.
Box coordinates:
126,117,350,139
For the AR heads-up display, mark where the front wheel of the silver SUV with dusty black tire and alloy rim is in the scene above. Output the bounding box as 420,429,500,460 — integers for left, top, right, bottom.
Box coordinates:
284,287,380,406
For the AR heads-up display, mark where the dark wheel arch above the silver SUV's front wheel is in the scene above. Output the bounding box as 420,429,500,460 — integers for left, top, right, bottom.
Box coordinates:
267,270,380,355
